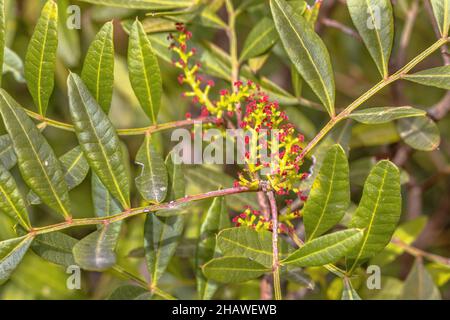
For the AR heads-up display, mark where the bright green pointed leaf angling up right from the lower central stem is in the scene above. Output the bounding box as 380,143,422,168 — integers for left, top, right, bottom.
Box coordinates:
282,229,363,267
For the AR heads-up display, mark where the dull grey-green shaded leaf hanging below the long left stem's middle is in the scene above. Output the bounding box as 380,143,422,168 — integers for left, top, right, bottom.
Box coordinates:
72,222,120,271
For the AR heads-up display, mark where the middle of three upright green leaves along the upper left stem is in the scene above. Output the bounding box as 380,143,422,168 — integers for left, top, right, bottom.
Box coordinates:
81,22,114,114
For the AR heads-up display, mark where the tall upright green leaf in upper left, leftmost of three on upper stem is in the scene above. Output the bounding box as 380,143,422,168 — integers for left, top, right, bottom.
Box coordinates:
25,0,58,115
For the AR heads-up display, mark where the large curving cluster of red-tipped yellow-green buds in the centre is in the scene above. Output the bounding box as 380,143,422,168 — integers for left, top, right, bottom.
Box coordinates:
169,24,308,196
